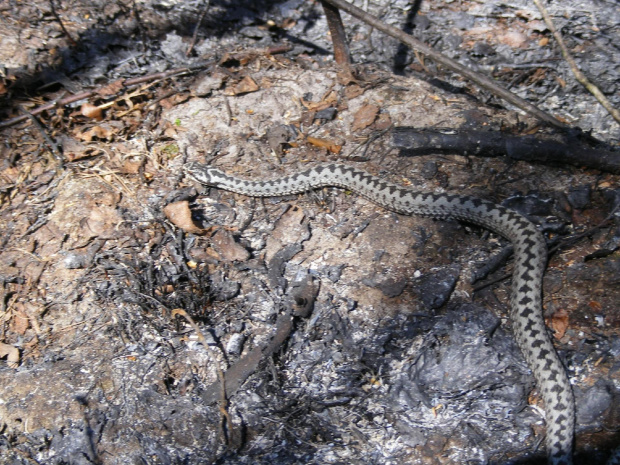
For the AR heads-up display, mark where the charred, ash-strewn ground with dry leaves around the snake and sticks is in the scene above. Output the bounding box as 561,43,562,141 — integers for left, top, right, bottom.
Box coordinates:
0,0,620,464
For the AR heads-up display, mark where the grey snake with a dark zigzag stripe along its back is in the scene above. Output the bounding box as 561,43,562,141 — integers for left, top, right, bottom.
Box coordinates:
184,163,575,465
